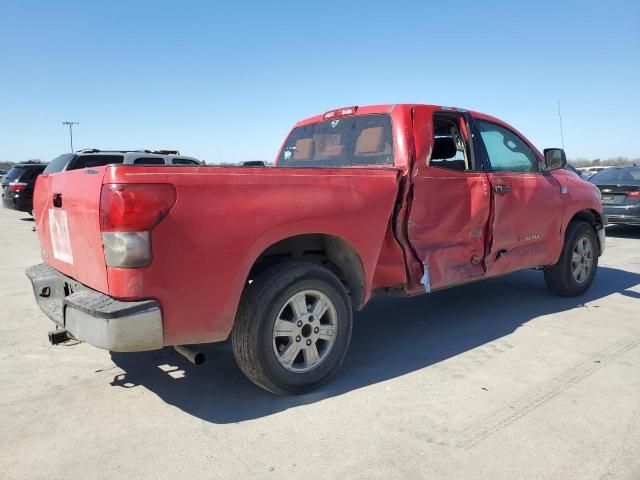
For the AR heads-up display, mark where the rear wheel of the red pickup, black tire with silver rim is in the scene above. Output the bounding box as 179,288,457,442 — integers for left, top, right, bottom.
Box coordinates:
231,261,352,395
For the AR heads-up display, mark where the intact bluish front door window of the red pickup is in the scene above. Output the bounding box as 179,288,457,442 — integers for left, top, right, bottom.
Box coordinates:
476,120,539,173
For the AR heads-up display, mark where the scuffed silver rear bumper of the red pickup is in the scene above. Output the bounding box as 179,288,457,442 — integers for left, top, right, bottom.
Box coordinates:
26,263,164,352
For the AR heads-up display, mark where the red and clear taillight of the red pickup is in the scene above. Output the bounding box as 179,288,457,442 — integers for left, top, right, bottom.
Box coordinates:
100,184,176,268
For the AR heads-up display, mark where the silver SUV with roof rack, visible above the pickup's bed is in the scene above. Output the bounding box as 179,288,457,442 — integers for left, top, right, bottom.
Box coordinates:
45,148,203,174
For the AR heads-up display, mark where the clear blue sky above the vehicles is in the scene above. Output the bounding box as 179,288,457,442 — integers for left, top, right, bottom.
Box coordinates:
0,0,640,162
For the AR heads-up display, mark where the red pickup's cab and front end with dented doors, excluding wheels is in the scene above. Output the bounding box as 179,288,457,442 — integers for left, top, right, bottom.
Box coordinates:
276,105,606,291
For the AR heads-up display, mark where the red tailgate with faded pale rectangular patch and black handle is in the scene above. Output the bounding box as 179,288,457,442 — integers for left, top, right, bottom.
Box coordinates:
33,167,108,293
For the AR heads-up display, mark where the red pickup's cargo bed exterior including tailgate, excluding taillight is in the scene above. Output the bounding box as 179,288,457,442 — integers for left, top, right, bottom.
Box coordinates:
34,165,401,345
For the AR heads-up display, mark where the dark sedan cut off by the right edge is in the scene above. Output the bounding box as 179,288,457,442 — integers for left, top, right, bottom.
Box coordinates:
589,165,640,225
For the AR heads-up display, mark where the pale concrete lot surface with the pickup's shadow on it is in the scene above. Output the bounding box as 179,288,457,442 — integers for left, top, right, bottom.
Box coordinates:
0,210,640,480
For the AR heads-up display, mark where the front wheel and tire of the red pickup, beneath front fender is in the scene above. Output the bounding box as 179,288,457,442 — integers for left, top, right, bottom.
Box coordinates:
544,221,600,297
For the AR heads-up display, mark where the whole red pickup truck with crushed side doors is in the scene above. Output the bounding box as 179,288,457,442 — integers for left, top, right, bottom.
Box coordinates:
27,104,606,394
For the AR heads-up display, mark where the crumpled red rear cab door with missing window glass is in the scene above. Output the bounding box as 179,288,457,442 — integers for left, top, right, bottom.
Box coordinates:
407,107,491,291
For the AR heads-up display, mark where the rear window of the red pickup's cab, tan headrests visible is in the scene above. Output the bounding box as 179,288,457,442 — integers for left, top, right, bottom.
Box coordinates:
278,115,394,168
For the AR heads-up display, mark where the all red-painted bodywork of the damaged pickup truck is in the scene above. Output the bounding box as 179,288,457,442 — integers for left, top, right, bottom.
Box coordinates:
34,105,602,345
